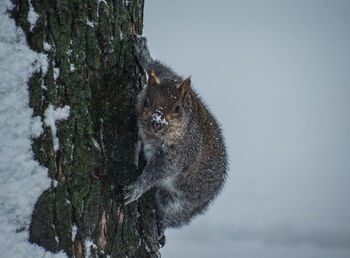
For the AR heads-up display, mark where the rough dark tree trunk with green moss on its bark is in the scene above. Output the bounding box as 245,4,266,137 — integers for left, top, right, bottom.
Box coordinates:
12,0,159,257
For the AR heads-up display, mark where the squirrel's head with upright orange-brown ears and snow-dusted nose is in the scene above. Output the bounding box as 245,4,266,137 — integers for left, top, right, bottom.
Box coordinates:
138,69,191,140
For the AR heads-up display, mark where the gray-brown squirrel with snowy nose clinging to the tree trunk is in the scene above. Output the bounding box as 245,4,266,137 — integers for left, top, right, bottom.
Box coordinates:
124,36,228,241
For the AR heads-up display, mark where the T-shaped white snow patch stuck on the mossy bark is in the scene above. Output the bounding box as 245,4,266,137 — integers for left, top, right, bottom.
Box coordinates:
44,104,70,152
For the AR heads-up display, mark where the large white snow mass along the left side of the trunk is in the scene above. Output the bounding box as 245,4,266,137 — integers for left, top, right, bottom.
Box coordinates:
0,0,67,257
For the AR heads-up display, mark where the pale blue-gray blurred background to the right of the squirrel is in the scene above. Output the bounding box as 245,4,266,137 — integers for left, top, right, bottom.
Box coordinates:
144,0,350,258
